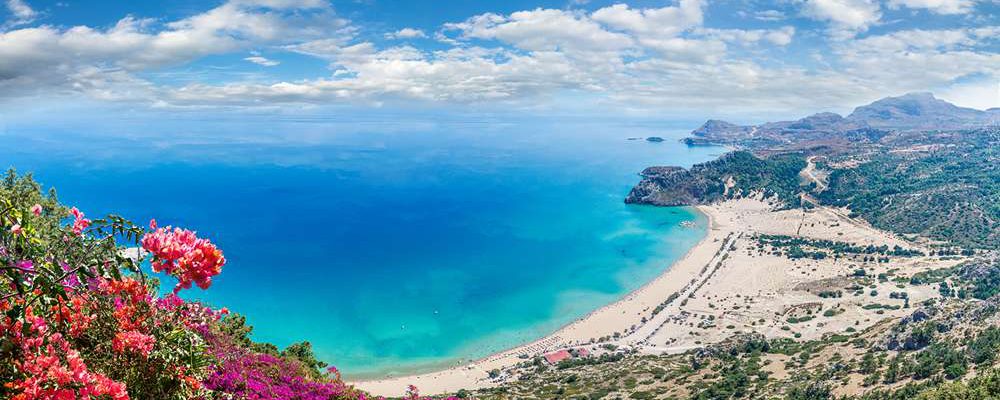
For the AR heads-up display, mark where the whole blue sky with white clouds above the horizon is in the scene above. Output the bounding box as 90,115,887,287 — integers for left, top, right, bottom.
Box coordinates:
0,0,1000,123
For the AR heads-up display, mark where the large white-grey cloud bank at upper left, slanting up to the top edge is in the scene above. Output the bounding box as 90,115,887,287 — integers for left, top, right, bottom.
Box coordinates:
0,0,352,97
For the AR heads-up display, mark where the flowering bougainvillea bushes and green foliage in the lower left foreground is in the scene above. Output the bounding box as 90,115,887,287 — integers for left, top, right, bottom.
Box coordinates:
0,171,454,400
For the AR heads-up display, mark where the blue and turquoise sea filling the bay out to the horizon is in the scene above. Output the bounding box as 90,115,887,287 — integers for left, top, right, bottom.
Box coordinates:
0,121,721,378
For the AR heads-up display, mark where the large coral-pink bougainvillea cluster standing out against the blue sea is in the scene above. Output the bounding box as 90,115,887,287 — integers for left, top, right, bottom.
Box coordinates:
142,220,226,293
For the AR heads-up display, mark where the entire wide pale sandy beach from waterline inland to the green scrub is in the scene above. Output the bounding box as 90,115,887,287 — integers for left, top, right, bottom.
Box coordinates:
354,199,959,396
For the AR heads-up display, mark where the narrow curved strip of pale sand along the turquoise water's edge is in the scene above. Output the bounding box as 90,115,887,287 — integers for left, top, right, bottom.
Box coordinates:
350,206,728,396
